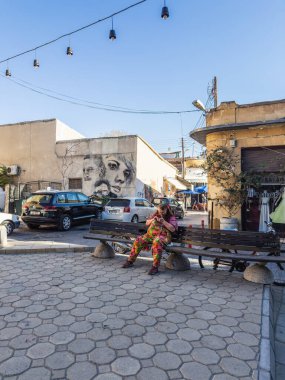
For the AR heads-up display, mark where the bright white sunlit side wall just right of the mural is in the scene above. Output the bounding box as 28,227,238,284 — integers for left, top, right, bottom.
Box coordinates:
136,137,177,199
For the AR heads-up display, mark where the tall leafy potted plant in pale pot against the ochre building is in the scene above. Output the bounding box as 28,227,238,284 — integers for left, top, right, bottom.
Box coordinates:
203,146,259,229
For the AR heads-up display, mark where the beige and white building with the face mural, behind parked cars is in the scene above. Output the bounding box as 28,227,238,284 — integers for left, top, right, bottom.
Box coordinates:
0,119,177,199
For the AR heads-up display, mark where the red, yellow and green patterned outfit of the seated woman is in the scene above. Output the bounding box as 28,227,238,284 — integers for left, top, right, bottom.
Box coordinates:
128,216,177,267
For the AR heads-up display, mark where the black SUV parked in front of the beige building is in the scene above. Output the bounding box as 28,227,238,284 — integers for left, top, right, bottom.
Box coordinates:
22,190,102,231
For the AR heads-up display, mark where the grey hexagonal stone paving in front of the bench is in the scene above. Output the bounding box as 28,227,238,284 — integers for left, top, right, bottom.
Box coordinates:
0,253,262,380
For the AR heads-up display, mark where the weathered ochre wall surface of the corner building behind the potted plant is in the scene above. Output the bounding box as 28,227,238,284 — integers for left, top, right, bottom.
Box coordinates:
206,101,285,227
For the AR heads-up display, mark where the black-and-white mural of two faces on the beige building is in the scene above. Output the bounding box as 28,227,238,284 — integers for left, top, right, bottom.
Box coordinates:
83,154,135,197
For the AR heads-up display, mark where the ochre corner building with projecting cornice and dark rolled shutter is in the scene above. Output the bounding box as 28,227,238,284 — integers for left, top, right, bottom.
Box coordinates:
190,100,285,231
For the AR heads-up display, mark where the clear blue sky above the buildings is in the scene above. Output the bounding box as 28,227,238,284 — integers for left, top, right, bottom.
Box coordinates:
0,0,285,154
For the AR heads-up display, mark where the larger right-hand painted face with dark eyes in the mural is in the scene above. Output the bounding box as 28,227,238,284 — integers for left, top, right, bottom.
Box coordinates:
102,155,134,195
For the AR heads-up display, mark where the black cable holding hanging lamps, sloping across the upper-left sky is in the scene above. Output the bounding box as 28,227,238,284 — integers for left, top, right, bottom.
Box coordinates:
0,0,147,63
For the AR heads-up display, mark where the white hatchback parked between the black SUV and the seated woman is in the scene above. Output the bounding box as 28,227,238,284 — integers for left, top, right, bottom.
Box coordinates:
102,198,156,223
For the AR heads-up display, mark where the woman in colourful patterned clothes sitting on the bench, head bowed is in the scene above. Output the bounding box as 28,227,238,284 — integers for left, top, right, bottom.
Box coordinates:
123,203,177,275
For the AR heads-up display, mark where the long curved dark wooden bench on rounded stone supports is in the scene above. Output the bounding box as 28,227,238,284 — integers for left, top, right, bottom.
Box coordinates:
84,219,285,282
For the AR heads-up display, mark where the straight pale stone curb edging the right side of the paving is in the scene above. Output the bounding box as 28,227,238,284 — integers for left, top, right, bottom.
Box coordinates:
258,285,275,380
